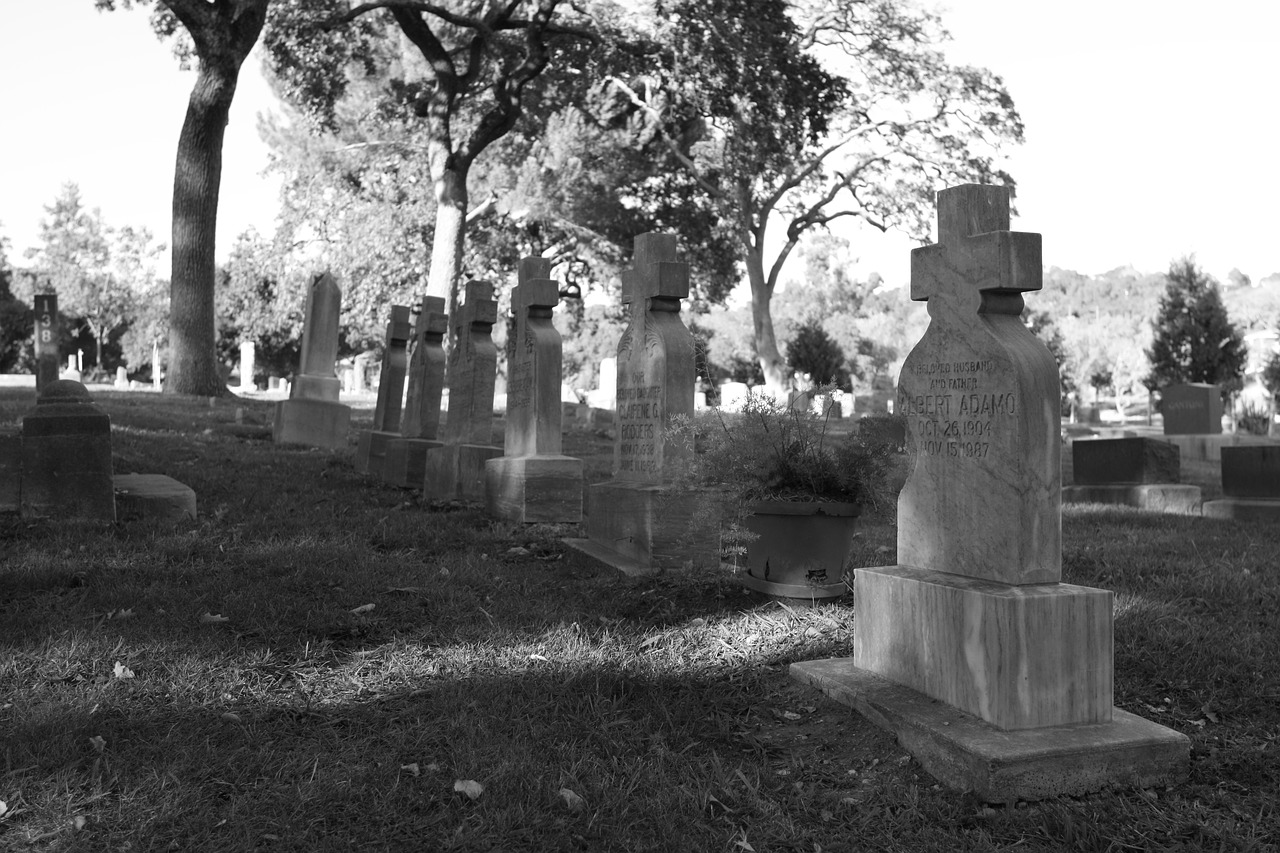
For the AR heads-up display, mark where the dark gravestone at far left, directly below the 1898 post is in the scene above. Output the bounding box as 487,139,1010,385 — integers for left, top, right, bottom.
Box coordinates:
20,379,115,521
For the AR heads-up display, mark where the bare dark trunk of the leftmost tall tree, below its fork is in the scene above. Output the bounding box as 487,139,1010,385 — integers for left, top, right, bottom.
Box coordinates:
164,60,239,397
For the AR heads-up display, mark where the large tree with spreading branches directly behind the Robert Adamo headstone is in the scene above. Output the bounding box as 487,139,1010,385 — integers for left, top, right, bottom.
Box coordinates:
614,0,1023,389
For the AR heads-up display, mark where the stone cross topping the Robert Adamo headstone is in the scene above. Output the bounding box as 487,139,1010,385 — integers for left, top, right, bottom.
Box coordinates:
911,184,1043,314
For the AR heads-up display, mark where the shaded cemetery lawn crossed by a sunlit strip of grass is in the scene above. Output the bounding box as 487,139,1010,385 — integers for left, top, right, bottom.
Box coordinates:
0,389,1280,853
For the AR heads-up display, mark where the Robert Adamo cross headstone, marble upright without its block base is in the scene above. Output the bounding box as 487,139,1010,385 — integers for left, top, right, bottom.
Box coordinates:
897,184,1061,584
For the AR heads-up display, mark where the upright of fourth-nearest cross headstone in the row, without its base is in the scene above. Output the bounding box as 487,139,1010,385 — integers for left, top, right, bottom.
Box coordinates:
444,282,498,444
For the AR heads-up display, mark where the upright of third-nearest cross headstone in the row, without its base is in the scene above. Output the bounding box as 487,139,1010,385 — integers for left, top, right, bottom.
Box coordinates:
503,257,561,456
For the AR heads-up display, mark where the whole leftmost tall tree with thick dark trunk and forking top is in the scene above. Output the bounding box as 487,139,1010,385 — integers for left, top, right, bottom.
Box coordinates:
95,0,270,396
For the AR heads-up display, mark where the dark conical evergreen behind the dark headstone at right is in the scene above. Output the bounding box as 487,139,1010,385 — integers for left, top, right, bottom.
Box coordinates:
1144,257,1247,394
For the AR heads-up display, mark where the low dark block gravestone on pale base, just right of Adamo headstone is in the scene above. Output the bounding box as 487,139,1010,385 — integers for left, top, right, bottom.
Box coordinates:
1062,438,1201,514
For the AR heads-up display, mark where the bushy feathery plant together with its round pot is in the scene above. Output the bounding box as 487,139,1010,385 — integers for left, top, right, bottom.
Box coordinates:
686,393,897,599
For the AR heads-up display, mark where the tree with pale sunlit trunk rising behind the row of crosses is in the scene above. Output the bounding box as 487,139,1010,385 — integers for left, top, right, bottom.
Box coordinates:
266,0,604,324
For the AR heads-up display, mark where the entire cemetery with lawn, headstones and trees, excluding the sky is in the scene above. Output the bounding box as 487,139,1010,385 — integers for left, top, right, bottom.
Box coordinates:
0,0,1280,853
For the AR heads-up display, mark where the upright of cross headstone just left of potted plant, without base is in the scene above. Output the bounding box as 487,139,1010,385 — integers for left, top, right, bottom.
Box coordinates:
613,233,695,483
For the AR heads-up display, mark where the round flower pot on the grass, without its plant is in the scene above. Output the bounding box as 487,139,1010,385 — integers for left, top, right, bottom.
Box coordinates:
742,501,861,599
